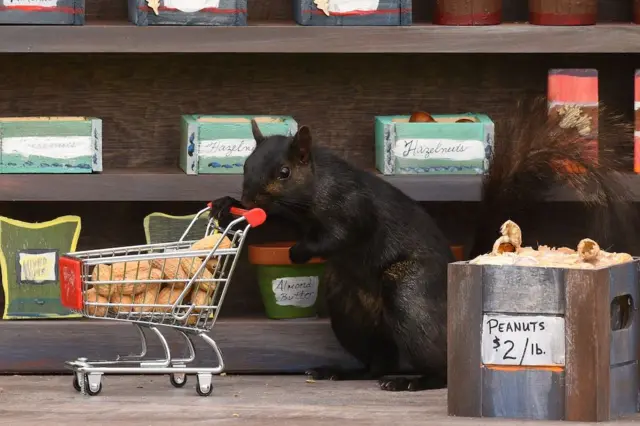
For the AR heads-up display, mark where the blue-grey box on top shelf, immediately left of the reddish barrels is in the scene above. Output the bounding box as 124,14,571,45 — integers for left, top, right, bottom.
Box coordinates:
293,0,412,26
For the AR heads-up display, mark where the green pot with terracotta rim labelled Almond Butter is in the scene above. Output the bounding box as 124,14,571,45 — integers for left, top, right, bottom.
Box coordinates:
249,243,324,319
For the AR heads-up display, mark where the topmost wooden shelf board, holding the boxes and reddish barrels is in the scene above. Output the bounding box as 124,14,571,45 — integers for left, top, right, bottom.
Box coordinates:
0,21,640,53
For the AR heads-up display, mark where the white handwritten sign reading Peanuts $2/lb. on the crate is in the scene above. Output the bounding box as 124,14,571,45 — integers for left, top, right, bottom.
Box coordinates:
482,314,565,366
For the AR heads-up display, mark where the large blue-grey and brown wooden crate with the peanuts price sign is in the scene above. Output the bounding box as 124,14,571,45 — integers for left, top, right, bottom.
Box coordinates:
447,259,640,422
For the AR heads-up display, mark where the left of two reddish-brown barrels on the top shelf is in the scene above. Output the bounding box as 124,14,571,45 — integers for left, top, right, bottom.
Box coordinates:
433,0,502,25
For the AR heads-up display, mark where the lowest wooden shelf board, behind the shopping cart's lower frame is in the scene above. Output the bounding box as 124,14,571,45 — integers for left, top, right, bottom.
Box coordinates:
0,319,358,373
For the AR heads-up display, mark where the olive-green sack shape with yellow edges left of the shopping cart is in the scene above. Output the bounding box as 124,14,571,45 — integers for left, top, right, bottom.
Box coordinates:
0,216,81,319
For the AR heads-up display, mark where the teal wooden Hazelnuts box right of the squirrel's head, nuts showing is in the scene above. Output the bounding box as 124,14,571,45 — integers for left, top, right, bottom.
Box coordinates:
375,113,494,175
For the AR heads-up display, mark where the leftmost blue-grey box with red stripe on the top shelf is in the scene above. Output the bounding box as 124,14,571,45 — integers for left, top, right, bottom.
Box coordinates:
0,0,85,25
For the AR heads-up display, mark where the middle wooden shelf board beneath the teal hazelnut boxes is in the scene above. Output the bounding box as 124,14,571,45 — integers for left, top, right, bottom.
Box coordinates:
0,169,640,202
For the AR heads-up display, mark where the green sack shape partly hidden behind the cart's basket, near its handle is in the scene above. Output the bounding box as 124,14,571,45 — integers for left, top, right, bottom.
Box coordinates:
143,213,209,244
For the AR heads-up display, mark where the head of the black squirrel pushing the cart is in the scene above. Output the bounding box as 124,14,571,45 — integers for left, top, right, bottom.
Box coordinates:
242,120,314,209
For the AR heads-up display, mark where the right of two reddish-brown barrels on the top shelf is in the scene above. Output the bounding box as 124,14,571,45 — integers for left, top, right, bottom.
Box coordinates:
529,0,598,25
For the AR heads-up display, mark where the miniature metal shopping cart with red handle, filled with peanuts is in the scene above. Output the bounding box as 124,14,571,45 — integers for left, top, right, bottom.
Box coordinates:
59,204,266,396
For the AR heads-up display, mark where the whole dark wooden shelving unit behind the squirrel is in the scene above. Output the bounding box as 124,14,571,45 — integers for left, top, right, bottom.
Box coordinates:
0,0,640,373
